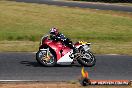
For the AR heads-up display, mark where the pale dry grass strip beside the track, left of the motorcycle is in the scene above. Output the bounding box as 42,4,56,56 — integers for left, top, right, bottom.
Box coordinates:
0,41,39,52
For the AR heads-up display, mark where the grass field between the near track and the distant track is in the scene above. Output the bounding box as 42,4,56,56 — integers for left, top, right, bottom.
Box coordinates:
0,1,132,55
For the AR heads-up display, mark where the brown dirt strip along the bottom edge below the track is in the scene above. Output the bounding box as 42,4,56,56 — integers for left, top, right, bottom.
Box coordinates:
0,82,132,88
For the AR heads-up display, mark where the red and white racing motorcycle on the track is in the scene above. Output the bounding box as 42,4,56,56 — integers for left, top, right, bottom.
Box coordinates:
36,35,96,67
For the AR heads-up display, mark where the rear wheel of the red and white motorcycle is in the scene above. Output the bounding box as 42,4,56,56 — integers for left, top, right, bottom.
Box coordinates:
78,51,96,67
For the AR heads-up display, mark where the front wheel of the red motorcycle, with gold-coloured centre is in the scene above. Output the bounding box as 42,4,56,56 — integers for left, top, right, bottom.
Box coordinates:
36,49,56,67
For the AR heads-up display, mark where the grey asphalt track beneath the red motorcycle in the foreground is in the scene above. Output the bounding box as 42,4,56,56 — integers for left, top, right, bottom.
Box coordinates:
0,53,132,81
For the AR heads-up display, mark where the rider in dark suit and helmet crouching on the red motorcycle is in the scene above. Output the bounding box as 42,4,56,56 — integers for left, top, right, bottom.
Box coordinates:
50,27,78,54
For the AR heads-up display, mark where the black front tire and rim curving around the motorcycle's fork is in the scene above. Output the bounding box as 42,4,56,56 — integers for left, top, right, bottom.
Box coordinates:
36,48,57,67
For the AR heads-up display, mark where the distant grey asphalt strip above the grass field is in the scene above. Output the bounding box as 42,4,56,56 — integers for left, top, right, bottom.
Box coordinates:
15,0,132,12
